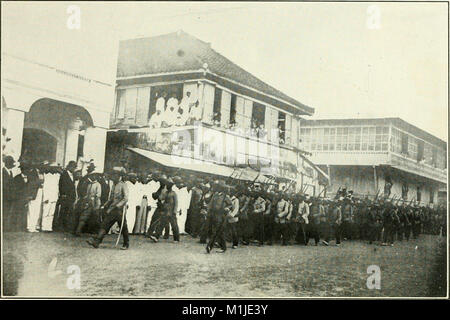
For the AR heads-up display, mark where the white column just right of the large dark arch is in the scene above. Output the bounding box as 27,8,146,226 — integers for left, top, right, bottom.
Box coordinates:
83,127,106,172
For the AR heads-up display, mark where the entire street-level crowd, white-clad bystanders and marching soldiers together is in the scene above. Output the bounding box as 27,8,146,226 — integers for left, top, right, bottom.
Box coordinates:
3,156,447,252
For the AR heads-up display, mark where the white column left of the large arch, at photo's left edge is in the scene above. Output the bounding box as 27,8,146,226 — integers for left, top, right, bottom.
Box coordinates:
4,109,25,161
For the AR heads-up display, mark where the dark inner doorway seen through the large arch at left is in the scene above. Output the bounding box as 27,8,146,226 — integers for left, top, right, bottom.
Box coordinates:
21,128,57,163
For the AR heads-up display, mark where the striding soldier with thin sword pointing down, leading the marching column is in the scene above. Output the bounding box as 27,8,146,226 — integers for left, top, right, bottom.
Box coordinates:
87,167,130,250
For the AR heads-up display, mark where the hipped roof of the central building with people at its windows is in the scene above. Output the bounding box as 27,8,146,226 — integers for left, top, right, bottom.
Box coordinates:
117,31,314,115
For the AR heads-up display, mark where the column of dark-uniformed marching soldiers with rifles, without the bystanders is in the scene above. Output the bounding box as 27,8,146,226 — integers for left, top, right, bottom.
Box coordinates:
88,168,446,253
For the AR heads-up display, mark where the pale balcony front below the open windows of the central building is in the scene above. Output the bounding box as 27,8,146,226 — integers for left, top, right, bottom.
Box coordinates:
113,122,299,180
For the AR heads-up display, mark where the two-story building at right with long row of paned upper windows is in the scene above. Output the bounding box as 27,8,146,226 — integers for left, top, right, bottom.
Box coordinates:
300,118,447,204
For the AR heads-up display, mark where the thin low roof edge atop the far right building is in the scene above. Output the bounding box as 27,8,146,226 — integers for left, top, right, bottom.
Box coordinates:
300,118,447,150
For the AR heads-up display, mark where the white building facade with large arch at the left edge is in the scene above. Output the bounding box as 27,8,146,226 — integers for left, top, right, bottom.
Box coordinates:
1,52,114,170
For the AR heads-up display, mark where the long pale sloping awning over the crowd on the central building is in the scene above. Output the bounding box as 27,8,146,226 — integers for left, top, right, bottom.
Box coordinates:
128,148,266,182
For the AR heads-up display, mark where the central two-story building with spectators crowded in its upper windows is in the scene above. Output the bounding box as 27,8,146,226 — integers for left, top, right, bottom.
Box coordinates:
107,31,326,191
